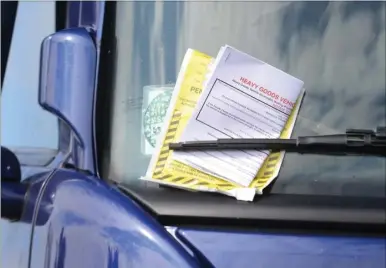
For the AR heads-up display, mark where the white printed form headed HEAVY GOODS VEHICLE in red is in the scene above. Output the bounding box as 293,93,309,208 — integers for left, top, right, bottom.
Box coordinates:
173,46,304,187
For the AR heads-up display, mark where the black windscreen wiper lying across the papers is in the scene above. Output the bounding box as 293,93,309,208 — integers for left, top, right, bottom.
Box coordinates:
169,127,386,156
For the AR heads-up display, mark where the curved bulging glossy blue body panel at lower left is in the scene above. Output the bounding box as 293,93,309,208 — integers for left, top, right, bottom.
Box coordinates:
31,170,205,268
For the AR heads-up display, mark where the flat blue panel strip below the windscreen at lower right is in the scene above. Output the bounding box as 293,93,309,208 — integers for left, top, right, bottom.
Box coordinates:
176,228,386,268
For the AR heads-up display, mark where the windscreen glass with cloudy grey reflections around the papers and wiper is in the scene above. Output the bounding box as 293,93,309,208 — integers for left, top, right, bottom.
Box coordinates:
108,1,386,196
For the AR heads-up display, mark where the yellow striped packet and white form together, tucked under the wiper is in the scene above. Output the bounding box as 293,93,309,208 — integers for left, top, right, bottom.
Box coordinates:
142,46,304,201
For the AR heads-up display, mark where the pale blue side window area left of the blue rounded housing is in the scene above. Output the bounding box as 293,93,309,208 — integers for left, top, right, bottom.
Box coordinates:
1,2,58,149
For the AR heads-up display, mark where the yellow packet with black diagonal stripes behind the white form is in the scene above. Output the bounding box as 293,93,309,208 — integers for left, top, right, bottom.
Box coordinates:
141,49,304,201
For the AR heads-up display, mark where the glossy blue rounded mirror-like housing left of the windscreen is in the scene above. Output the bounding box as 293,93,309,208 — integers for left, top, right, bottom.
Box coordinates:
39,28,97,174
